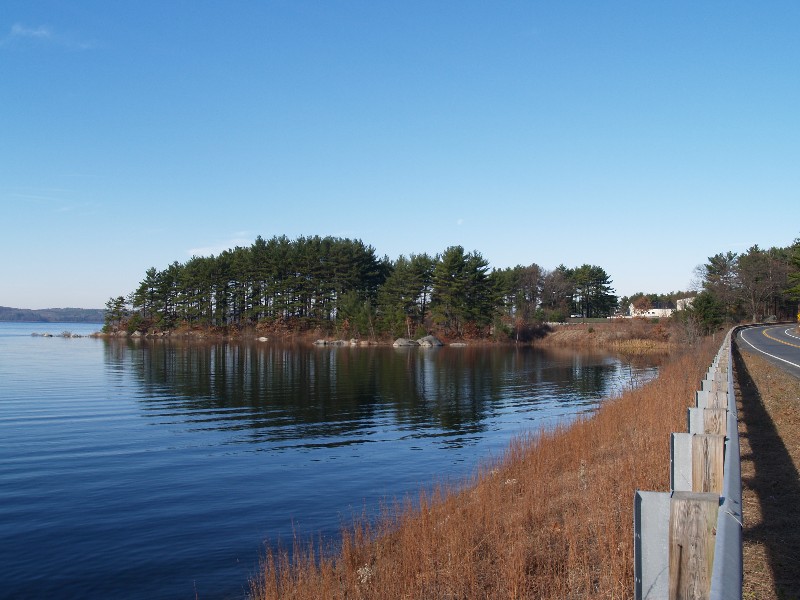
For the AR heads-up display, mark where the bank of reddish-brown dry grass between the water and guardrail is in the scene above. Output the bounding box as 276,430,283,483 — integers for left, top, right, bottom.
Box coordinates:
251,343,717,600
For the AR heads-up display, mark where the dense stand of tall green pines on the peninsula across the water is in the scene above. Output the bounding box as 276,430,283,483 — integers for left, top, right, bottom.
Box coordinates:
106,236,617,339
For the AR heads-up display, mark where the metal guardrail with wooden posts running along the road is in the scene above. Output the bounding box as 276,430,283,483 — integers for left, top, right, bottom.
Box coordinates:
634,330,742,600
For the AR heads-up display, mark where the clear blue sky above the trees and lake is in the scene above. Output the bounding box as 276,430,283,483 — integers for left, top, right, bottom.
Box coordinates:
0,0,800,308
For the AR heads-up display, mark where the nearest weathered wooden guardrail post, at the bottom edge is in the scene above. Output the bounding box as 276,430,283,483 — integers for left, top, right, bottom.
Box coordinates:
669,492,719,600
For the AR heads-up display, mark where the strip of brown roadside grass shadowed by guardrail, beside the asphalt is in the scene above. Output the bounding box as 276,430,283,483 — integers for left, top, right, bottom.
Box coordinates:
736,344,800,600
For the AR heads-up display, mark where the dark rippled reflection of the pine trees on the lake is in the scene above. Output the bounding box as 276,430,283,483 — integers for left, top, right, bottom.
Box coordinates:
105,340,658,448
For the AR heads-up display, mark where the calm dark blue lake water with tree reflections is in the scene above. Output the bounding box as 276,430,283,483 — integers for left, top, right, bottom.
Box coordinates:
0,323,657,599
